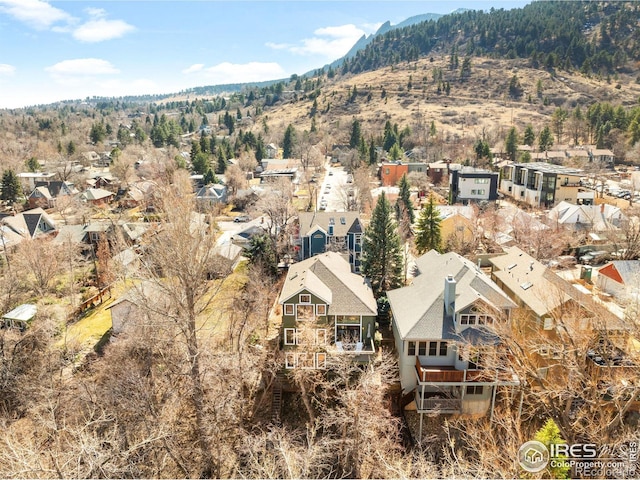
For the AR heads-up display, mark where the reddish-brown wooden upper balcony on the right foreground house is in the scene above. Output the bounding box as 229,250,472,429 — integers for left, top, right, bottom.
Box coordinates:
416,357,520,385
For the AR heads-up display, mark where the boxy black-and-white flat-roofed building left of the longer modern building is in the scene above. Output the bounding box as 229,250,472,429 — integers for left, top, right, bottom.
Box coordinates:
449,167,499,204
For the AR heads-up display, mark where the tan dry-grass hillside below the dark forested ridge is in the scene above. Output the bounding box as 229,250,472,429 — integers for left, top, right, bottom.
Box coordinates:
256,56,640,147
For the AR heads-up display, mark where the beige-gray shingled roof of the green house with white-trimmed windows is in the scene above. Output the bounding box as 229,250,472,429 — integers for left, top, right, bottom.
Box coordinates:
279,252,378,315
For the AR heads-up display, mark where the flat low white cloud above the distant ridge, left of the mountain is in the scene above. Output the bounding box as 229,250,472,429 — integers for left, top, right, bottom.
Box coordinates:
183,62,287,84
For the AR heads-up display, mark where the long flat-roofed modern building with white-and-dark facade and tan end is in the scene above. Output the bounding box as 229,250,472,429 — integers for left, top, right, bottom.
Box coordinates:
499,162,595,208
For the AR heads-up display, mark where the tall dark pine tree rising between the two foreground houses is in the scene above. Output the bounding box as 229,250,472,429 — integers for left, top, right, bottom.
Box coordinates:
362,193,403,298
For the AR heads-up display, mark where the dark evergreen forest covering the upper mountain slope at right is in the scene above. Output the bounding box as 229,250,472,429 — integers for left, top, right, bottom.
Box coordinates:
341,2,640,78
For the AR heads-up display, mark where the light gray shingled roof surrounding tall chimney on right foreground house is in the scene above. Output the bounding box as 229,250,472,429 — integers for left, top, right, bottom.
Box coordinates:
387,250,516,340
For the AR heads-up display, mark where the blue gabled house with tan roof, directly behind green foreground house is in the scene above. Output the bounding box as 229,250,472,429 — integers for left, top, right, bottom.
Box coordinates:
294,212,364,273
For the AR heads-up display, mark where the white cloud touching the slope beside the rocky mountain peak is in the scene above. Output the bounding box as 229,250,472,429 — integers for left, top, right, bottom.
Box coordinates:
267,24,371,60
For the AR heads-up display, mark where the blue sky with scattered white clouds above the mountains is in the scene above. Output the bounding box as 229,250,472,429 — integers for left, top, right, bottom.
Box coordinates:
0,0,530,108
